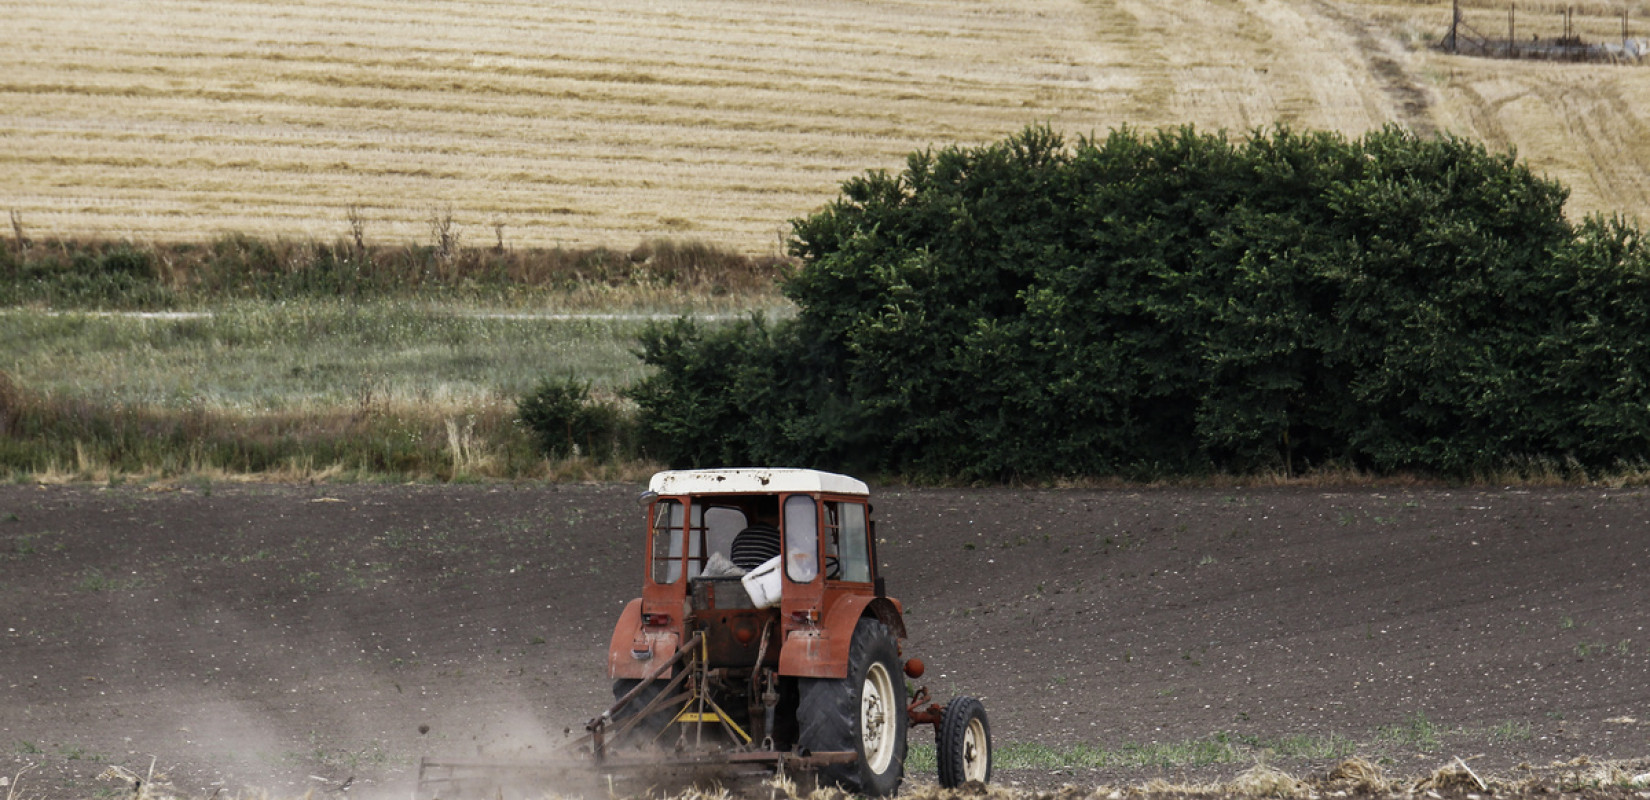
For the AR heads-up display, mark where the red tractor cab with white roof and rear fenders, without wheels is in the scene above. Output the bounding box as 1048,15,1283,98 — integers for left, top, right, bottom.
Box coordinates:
609,470,884,678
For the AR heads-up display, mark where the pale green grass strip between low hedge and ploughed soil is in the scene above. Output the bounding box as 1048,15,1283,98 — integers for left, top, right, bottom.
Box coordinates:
0,300,735,480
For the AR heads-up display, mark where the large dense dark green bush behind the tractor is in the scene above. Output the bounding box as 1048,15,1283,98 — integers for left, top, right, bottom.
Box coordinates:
634,121,1650,478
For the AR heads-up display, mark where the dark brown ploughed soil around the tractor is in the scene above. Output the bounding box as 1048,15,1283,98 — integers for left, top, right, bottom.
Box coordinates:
0,485,1650,800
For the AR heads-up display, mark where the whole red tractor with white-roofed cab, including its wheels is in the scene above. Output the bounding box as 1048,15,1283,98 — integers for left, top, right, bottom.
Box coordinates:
587,468,992,797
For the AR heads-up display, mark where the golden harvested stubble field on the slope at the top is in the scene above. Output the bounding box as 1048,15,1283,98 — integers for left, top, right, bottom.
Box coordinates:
16,0,1650,254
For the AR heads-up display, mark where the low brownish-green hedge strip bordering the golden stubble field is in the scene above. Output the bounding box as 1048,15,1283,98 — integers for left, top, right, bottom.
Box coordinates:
0,233,782,310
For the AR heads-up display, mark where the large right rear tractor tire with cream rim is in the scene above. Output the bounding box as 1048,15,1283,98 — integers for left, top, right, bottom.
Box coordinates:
797,617,908,797
